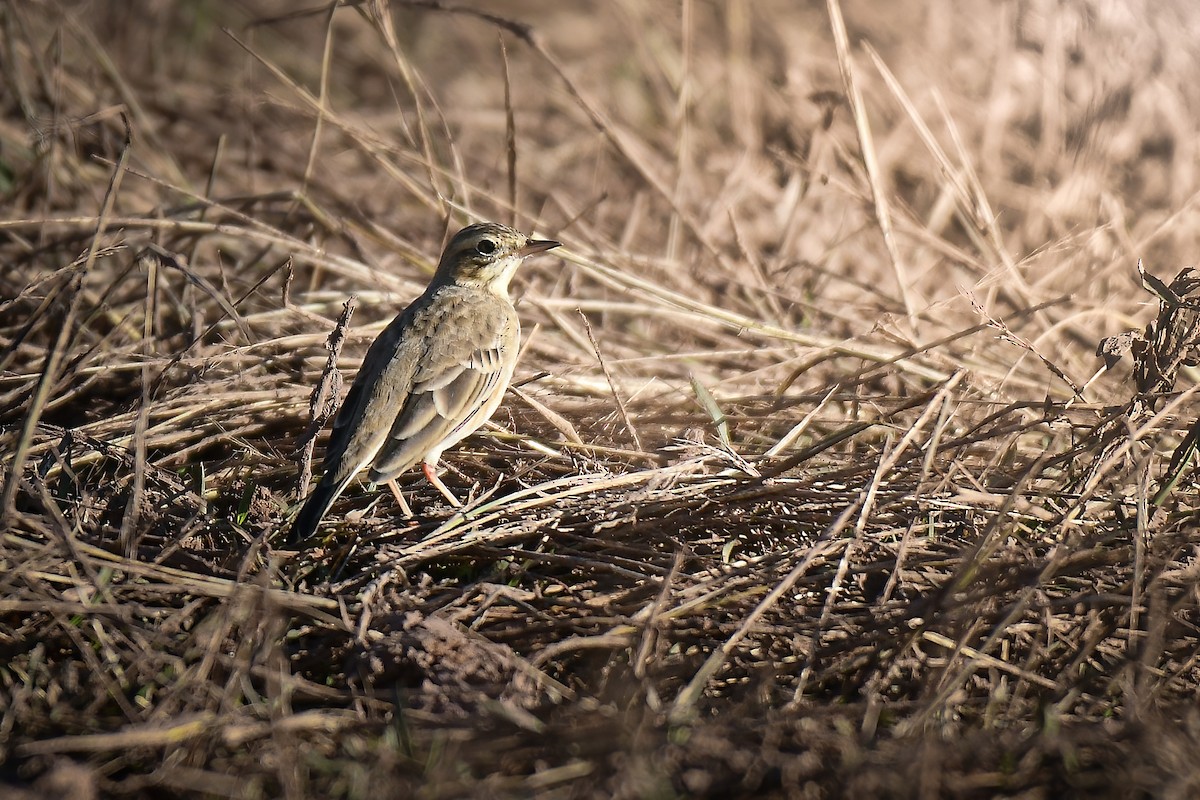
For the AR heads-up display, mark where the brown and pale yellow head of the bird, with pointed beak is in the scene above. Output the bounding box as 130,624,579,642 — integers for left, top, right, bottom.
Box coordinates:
437,222,560,295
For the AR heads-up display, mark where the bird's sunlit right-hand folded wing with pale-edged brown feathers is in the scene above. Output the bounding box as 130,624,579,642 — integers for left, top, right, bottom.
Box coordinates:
371,296,518,481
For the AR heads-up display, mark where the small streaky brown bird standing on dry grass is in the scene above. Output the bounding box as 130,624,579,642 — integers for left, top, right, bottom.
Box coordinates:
288,222,559,542
